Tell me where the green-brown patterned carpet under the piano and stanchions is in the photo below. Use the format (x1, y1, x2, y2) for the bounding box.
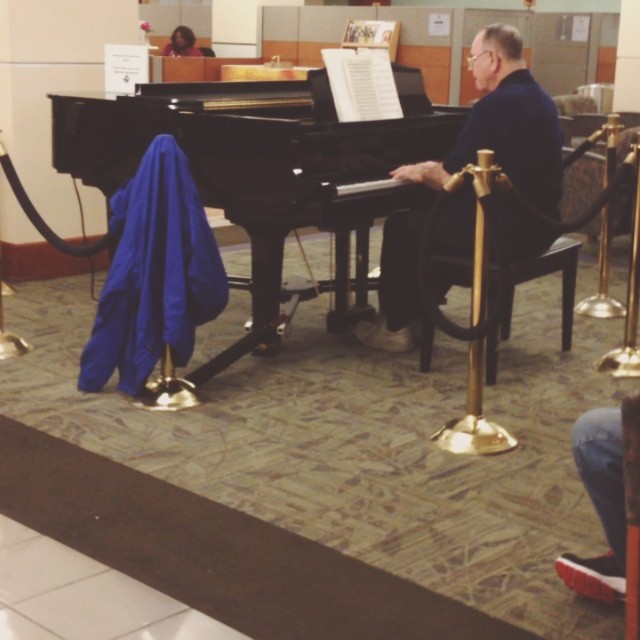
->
(0, 229, 637, 640)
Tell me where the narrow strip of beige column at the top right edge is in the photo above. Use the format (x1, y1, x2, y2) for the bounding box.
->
(613, 0, 640, 112)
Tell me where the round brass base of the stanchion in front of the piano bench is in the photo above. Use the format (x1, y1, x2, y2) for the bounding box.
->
(432, 415, 518, 456)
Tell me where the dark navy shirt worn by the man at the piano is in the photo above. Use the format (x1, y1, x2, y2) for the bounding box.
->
(443, 69, 562, 253)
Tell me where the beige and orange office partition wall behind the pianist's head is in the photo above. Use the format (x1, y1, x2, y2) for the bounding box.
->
(262, 2, 619, 104)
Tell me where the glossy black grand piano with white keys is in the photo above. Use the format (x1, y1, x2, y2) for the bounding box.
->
(49, 65, 465, 360)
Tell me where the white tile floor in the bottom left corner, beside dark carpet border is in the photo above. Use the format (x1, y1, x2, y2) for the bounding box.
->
(0, 515, 252, 640)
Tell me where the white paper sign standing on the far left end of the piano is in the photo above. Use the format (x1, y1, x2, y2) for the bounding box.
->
(104, 44, 149, 95)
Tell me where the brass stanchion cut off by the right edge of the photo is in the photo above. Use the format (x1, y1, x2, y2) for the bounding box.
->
(595, 137, 640, 378)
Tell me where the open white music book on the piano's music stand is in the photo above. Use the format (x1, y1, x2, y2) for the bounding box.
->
(322, 49, 403, 122)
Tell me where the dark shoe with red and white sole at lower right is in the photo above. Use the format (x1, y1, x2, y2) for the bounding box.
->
(556, 552, 627, 604)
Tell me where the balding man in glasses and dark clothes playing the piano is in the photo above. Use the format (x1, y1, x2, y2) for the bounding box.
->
(355, 24, 562, 352)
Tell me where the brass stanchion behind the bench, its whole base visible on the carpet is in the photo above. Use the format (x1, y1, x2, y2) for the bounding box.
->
(575, 113, 626, 319)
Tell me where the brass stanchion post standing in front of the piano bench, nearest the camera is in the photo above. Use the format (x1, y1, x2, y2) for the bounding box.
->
(432, 149, 518, 455)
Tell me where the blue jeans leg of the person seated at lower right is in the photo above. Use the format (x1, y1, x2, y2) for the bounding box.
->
(572, 407, 627, 573)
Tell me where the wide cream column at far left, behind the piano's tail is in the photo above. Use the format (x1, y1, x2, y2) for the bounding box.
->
(0, 0, 139, 245)
